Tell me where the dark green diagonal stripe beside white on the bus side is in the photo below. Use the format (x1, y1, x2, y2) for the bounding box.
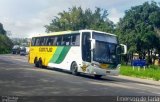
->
(56, 46, 71, 64)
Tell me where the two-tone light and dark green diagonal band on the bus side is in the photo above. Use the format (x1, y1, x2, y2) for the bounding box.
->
(50, 46, 71, 64)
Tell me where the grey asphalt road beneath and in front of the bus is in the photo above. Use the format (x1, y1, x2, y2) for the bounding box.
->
(0, 54, 160, 96)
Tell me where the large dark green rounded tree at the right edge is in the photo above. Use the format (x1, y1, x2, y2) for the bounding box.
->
(117, 1, 160, 63)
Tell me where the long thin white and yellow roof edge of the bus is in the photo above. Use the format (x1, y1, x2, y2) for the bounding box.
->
(33, 30, 116, 37)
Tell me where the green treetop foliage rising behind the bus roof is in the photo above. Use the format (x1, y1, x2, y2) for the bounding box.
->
(45, 7, 114, 33)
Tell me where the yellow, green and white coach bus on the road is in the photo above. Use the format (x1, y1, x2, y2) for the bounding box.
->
(28, 30, 127, 78)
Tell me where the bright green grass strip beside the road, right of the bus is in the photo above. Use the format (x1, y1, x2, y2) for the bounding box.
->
(120, 65, 160, 81)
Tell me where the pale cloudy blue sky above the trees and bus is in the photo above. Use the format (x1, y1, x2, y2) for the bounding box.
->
(0, 0, 160, 38)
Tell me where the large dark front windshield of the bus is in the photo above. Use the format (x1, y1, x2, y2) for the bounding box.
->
(93, 33, 117, 63)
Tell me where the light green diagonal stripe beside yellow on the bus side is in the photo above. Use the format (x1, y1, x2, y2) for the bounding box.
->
(49, 46, 64, 63)
